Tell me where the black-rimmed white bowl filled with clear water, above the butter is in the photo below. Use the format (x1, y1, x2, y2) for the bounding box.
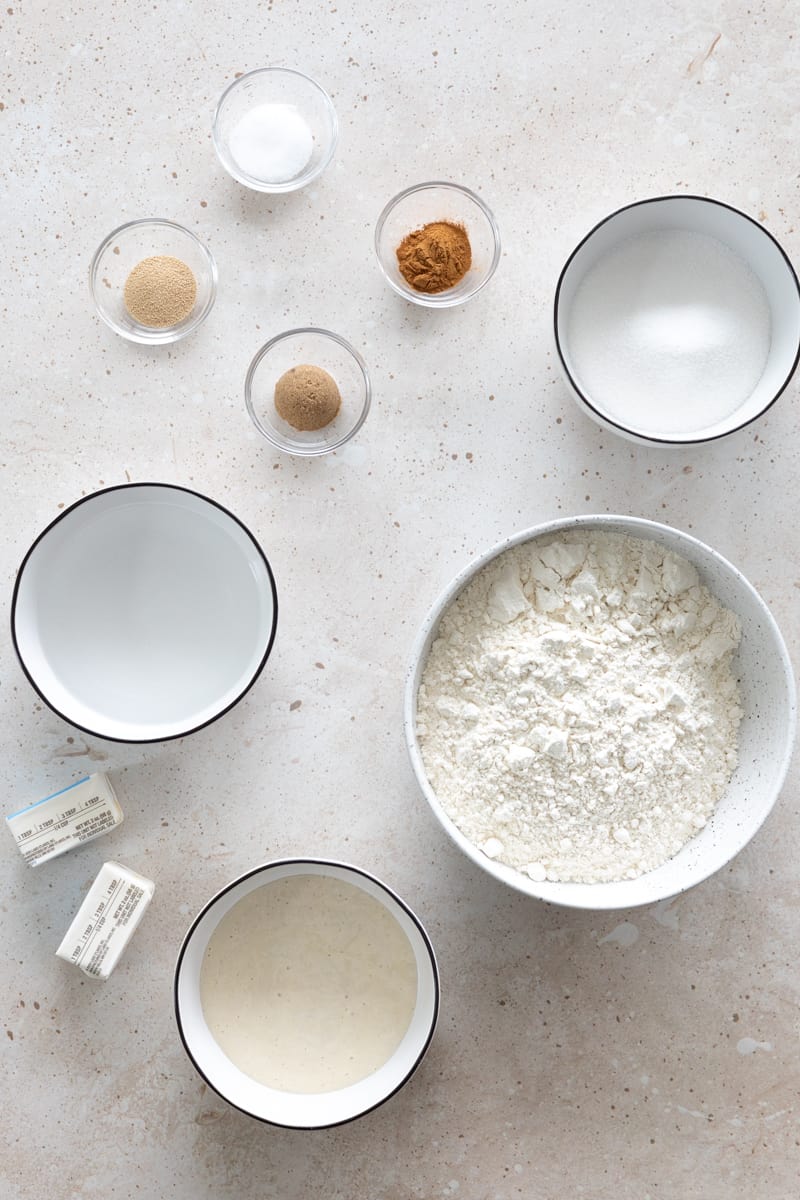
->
(11, 484, 277, 742)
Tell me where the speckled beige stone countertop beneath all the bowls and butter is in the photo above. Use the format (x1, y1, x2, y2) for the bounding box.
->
(0, 0, 800, 1200)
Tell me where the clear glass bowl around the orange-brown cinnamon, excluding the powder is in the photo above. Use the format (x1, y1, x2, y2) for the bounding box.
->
(375, 182, 500, 308)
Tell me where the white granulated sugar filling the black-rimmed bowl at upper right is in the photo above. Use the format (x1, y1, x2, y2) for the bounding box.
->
(567, 229, 770, 437)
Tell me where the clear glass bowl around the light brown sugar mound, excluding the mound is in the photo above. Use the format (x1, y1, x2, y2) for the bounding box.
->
(245, 326, 372, 457)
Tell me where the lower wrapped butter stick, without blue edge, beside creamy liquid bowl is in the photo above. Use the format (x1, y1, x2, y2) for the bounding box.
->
(55, 863, 156, 980)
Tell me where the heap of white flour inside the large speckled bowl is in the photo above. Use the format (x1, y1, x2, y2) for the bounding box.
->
(417, 532, 741, 883)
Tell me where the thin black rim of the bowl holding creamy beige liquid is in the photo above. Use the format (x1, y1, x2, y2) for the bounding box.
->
(173, 858, 440, 1130)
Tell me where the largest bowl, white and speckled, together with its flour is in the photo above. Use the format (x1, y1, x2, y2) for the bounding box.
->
(404, 516, 796, 908)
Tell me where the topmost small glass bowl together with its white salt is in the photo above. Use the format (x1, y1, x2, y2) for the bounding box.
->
(212, 67, 338, 192)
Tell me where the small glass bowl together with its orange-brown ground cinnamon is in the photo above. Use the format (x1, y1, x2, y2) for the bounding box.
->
(375, 182, 500, 308)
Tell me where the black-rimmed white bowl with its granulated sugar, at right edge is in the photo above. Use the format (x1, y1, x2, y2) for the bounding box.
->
(554, 196, 800, 445)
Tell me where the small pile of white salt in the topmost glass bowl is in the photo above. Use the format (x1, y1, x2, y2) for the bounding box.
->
(228, 104, 314, 184)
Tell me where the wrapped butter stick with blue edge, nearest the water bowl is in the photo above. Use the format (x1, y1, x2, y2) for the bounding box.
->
(6, 774, 122, 866)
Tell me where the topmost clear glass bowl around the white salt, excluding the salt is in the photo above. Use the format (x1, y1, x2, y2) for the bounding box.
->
(211, 67, 339, 192)
